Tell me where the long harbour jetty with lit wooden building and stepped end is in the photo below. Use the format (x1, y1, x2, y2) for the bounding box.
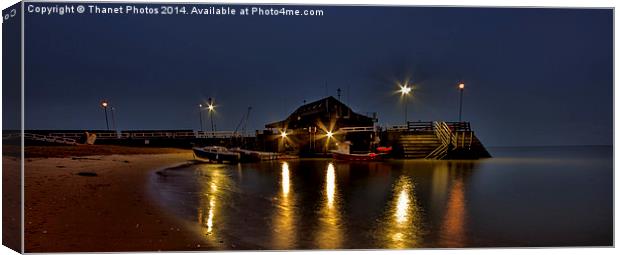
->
(12, 96, 491, 159)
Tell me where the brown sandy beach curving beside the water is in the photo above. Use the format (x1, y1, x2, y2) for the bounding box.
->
(24, 150, 225, 252)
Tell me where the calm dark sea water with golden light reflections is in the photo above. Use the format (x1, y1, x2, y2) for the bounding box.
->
(152, 147, 613, 249)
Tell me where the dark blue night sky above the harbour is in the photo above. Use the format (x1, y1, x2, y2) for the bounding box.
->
(25, 4, 613, 146)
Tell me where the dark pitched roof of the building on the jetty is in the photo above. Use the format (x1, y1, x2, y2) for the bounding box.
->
(265, 96, 374, 129)
